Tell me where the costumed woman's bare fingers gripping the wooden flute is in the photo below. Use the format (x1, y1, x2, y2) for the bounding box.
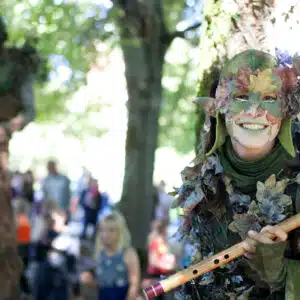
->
(243, 225, 288, 259)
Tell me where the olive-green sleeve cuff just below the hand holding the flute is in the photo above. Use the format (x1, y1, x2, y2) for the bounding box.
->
(249, 242, 288, 291)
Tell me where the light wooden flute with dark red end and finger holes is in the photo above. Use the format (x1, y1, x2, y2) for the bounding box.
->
(144, 213, 300, 300)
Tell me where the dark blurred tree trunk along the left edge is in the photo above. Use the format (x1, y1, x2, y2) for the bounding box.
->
(0, 17, 39, 299)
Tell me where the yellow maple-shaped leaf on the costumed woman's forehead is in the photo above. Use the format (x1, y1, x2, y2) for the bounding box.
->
(249, 69, 280, 95)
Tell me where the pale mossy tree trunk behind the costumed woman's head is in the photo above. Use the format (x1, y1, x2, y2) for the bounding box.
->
(196, 0, 274, 151)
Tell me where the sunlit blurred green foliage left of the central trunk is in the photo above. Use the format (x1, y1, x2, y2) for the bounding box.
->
(0, 0, 109, 138)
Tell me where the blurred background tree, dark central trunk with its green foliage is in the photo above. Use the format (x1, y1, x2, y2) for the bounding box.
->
(0, 0, 200, 247)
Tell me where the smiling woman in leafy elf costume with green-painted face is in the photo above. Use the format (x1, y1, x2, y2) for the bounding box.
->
(175, 50, 300, 300)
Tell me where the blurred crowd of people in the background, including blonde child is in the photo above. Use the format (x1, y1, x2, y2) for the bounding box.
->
(11, 161, 182, 300)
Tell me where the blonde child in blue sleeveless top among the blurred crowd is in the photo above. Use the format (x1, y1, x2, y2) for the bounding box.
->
(81, 212, 140, 300)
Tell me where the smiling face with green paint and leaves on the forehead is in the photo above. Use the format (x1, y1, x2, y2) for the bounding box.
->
(222, 69, 282, 149)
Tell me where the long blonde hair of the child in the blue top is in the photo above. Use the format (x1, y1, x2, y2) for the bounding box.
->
(95, 211, 131, 258)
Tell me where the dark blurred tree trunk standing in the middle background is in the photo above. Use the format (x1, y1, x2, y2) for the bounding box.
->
(115, 0, 168, 249)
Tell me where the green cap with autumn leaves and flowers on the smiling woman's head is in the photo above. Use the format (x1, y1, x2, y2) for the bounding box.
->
(216, 52, 300, 117)
